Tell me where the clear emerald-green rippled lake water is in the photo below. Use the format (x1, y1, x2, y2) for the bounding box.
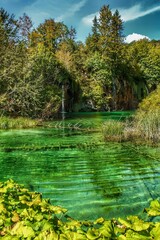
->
(0, 113, 160, 220)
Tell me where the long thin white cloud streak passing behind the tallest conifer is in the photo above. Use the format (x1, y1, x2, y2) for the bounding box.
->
(82, 4, 160, 26)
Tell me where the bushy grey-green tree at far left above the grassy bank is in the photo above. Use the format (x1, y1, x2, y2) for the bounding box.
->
(0, 43, 42, 117)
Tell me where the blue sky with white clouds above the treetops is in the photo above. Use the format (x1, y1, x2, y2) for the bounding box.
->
(0, 0, 160, 41)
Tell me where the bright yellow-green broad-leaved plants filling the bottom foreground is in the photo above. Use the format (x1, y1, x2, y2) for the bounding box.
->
(0, 180, 160, 240)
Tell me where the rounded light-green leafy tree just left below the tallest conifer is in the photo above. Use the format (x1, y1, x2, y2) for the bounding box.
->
(85, 52, 112, 110)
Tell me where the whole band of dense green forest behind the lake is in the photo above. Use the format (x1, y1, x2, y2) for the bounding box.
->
(0, 5, 160, 119)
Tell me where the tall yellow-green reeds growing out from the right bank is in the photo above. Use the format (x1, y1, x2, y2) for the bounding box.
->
(102, 108, 160, 144)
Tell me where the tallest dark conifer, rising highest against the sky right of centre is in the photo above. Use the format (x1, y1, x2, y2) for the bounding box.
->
(86, 5, 123, 109)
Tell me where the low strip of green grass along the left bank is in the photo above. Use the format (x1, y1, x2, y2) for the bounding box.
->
(0, 117, 39, 129)
